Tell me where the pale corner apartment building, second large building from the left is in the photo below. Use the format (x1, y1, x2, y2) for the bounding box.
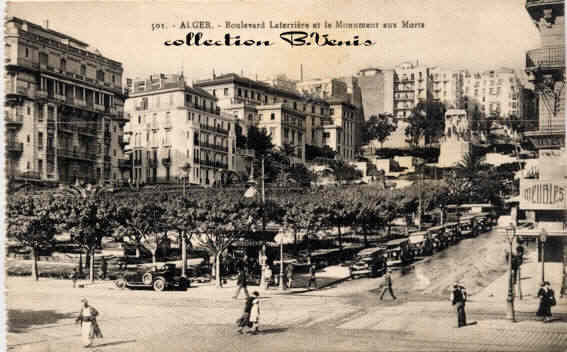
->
(125, 74, 235, 185)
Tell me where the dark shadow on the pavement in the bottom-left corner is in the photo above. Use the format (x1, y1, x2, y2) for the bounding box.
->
(8, 309, 76, 333)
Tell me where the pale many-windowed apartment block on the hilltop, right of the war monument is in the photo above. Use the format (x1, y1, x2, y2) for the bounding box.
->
(461, 68, 525, 118)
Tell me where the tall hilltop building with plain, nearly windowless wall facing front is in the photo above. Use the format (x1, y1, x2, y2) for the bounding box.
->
(357, 68, 394, 120)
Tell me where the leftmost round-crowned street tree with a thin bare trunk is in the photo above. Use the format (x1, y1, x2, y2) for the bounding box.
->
(6, 197, 58, 281)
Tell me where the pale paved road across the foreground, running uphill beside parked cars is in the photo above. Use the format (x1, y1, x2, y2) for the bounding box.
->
(7, 230, 567, 351)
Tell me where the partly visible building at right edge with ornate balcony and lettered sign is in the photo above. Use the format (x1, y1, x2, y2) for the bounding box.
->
(517, 0, 567, 289)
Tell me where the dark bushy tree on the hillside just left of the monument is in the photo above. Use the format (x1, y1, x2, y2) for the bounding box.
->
(405, 102, 445, 147)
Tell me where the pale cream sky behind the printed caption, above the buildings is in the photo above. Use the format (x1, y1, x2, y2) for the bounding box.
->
(6, 0, 540, 80)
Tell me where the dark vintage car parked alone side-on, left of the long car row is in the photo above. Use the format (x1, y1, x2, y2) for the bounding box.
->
(115, 264, 191, 291)
